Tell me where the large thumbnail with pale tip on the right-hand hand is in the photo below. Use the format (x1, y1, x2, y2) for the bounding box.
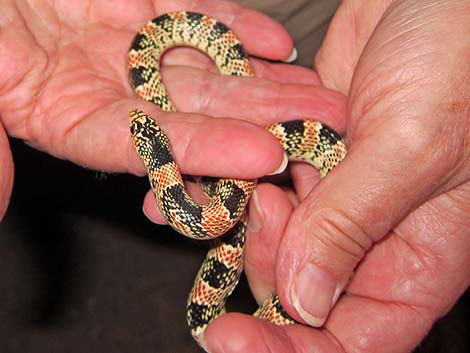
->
(291, 263, 336, 327)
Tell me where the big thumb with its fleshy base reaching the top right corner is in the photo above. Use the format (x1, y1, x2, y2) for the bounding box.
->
(276, 1, 470, 326)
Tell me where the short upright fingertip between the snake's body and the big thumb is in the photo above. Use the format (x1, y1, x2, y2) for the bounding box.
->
(245, 184, 293, 304)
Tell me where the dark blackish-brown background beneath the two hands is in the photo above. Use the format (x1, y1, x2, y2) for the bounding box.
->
(0, 135, 470, 353)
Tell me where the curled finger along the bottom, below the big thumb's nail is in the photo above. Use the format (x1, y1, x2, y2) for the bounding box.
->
(204, 183, 470, 353)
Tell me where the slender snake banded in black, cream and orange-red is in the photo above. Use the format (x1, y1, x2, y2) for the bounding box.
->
(128, 11, 347, 344)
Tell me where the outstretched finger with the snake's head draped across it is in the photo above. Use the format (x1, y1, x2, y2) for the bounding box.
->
(43, 100, 284, 178)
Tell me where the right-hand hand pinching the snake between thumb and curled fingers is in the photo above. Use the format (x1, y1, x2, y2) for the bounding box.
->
(205, 0, 470, 353)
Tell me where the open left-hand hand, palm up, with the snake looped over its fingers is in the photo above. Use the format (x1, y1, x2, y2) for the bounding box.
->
(0, 0, 345, 219)
